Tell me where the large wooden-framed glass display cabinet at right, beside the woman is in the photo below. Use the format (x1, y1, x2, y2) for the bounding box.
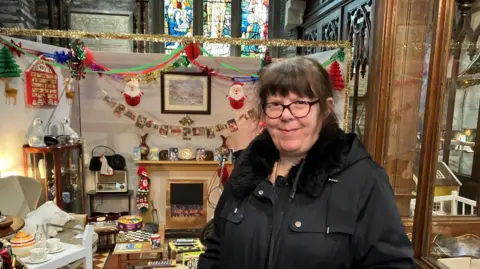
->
(365, 0, 480, 269)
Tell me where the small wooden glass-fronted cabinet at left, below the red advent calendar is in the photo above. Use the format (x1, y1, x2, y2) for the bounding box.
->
(23, 144, 85, 214)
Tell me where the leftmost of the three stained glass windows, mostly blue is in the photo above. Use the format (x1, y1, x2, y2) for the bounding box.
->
(164, 0, 193, 53)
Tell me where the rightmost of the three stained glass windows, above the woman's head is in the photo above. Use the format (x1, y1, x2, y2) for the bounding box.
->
(241, 0, 268, 57)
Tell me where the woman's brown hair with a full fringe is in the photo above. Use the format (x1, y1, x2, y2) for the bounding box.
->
(255, 56, 338, 127)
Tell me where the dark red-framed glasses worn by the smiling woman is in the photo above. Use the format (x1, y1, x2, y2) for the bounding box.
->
(263, 100, 319, 119)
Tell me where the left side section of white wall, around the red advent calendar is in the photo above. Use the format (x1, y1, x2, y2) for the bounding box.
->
(0, 36, 71, 176)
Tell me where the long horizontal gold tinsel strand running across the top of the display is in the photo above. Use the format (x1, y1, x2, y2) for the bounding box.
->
(0, 28, 351, 48)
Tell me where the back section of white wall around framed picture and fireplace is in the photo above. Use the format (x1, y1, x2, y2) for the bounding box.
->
(80, 52, 259, 218)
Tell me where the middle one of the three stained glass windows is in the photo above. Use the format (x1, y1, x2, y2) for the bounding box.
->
(203, 0, 232, 57)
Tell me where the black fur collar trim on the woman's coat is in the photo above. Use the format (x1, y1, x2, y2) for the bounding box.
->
(229, 125, 369, 199)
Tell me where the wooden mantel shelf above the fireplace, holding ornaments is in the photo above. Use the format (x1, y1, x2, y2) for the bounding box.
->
(136, 161, 233, 172)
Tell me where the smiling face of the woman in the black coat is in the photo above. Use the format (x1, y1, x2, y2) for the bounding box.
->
(264, 93, 322, 157)
